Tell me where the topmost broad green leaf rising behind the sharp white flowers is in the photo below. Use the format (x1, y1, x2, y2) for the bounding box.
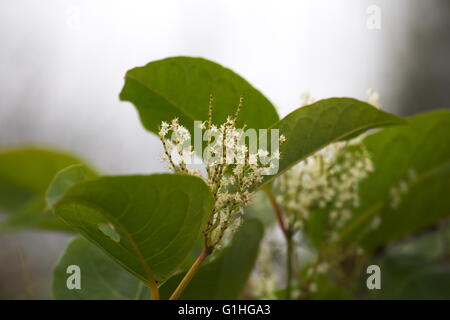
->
(120, 57, 278, 133)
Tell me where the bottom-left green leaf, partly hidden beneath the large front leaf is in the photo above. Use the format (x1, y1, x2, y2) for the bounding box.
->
(52, 236, 149, 300)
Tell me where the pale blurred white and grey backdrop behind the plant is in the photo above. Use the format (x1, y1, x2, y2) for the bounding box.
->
(0, 0, 449, 298)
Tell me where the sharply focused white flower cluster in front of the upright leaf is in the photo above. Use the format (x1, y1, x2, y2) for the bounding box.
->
(159, 98, 285, 248)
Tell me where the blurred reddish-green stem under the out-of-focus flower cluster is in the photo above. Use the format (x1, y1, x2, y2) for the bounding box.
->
(264, 186, 294, 300)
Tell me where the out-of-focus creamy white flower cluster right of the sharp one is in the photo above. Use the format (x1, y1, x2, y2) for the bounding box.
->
(275, 142, 373, 235)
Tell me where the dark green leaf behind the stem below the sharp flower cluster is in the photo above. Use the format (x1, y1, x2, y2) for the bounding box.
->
(161, 219, 263, 300)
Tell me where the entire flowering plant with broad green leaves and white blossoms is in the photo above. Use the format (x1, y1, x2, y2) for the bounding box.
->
(0, 57, 450, 299)
